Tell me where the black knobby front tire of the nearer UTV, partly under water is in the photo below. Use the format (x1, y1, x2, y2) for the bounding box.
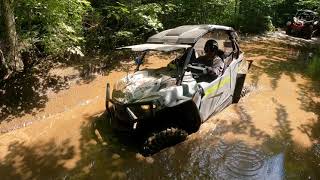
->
(141, 128, 188, 156)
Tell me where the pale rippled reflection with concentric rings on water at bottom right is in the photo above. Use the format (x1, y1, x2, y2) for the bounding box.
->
(176, 141, 283, 179)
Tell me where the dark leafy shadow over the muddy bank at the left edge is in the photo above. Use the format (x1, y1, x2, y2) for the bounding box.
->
(0, 62, 68, 123)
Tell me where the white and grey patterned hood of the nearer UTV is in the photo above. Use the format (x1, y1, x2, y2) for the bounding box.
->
(112, 71, 196, 106)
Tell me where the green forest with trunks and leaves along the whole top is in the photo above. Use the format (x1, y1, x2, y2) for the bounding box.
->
(0, 0, 320, 79)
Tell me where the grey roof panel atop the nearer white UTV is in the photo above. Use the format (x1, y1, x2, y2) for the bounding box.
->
(147, 25, 234, 44)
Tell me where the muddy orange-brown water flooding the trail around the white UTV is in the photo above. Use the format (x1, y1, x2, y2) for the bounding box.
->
(0, 32, 320, 179)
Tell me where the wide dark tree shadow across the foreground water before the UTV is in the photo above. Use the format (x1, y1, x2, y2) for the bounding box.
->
(0, 107, 319, 179)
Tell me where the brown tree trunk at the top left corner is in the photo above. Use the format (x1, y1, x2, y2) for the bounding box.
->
(0, 0, 23, 71)
